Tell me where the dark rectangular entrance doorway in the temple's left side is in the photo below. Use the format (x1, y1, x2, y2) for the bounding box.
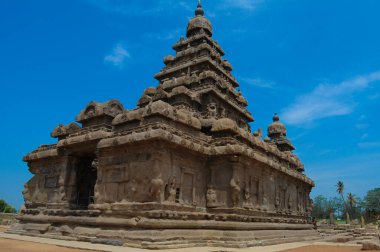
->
(75, 157, 97, 209)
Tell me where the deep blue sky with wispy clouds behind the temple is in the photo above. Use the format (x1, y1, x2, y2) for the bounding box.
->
(0, 0, 380, 207)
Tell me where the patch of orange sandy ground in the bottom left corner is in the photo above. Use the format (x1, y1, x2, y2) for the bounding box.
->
(0, 239, 94, 252)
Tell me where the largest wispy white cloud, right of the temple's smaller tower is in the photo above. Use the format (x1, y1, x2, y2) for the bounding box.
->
(282, 71, 380, 125)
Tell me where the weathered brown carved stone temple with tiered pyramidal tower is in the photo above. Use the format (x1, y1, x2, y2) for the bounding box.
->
(9, 3, 317, 249)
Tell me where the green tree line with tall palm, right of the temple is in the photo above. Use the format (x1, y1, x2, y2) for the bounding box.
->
(312, 181, 380, 222)
